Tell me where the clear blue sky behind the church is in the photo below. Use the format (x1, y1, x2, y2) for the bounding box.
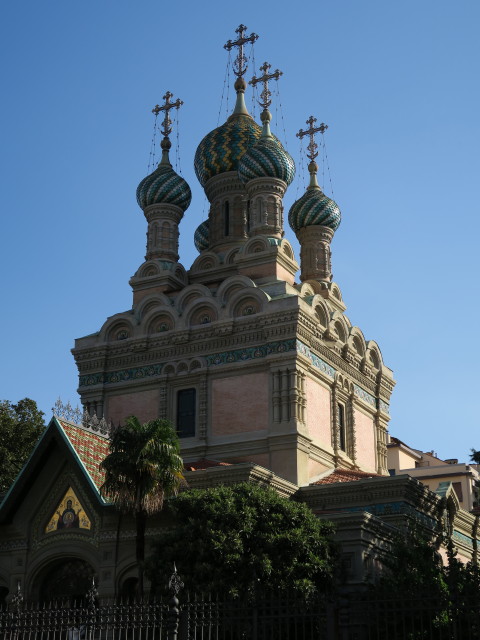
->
(0, 0, 480, 460)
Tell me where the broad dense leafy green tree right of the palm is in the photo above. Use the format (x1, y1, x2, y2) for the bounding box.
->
(147, 483, 335, 596)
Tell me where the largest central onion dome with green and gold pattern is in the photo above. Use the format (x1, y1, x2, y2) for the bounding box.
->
(194, 114, 262, 187)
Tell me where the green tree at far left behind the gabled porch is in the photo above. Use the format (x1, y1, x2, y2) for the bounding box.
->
(0, 398, 45, 493)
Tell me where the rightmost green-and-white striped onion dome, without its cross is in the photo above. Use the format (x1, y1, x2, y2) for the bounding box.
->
(288, 162, 342, 233)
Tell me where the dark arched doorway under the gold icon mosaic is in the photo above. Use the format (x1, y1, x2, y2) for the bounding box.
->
(35, 558, 95, 605)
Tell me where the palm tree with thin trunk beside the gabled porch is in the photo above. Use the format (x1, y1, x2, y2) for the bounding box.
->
(100, 416, 185, 598)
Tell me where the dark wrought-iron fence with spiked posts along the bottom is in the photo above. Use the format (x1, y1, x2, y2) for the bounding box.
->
(0, 581, 480, 640)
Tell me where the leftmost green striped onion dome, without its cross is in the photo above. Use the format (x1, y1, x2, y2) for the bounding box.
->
(137, 138, 192, 211)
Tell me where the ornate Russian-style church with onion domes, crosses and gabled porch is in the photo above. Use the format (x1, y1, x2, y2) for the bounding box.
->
(0, 25, 477, 598)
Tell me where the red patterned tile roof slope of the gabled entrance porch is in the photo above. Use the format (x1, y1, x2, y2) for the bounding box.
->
(58, 418, 109, 489)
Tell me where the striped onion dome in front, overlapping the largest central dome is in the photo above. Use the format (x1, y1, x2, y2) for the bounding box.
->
(238, 137, 295, 185)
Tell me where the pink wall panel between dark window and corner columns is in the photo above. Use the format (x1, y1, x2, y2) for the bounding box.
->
(211, 372, 269, 436)
